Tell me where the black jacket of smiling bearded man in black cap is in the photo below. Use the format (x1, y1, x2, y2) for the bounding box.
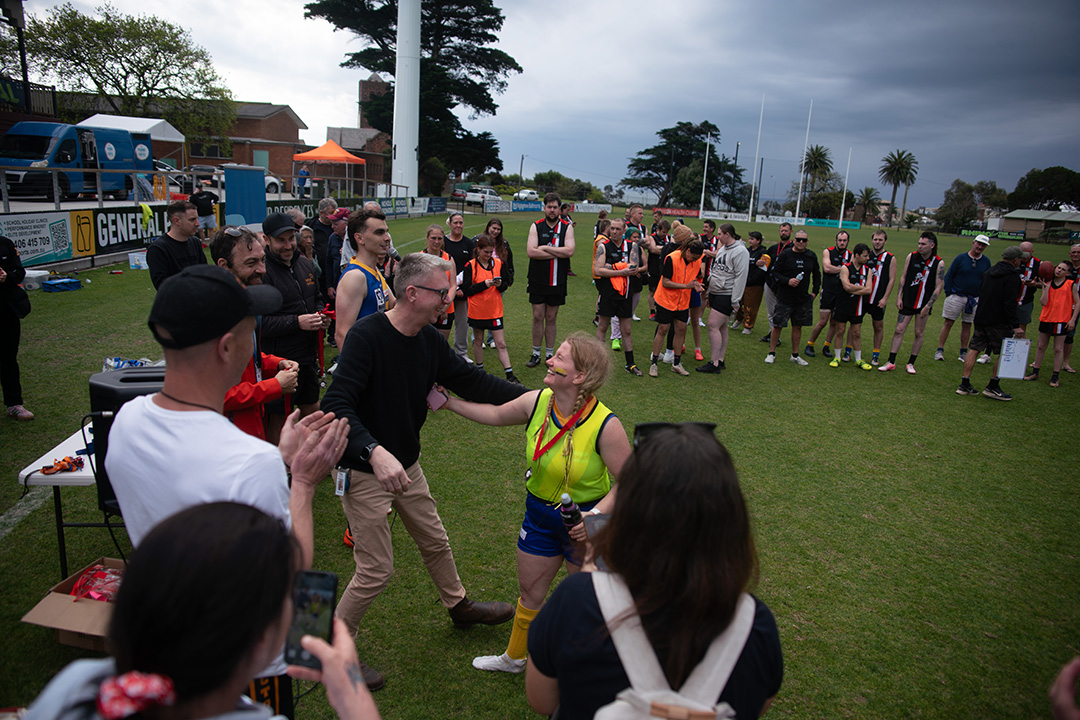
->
(261, 249, 324, 365)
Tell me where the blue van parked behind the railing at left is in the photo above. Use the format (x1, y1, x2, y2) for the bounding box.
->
(0, 122, 153, 200)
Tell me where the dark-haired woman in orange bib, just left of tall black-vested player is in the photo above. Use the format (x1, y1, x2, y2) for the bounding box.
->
(461, 234, 519, 384)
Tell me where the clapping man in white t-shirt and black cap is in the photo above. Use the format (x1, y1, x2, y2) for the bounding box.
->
(105, 266, 348, 717)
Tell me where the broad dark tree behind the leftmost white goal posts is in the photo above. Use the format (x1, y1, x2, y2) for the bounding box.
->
(620, 120, 742, 206)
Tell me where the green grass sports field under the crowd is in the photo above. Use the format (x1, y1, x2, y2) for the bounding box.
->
(0, 216, 1080, 719)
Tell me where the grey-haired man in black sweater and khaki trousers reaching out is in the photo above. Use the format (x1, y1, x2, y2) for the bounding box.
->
(322, 253, 526, 689)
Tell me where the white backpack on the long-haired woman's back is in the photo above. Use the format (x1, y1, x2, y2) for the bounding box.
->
(592, 572, 755, 720)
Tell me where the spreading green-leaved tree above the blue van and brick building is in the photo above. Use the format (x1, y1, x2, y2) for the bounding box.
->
(26, 2, 237, 144)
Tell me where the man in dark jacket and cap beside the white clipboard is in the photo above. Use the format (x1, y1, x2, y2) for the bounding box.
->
(956, 245, 1030, 400)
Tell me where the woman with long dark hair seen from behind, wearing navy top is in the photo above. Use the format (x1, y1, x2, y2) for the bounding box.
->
(525, 423, 784, 720)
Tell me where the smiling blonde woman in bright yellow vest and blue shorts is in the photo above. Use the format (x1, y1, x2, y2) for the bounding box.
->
(446, 332, 630, 673)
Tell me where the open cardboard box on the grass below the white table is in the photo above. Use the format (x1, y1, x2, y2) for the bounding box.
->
(23, 557, 124, 652)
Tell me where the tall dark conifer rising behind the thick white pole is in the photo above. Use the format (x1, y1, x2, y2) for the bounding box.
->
(305, 0, 522, 175)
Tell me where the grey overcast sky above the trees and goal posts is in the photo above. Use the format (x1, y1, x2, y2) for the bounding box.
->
(16, 0, 1080, 207)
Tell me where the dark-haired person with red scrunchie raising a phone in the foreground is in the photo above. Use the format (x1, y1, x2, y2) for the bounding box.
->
(26, 502, 379, 720)
